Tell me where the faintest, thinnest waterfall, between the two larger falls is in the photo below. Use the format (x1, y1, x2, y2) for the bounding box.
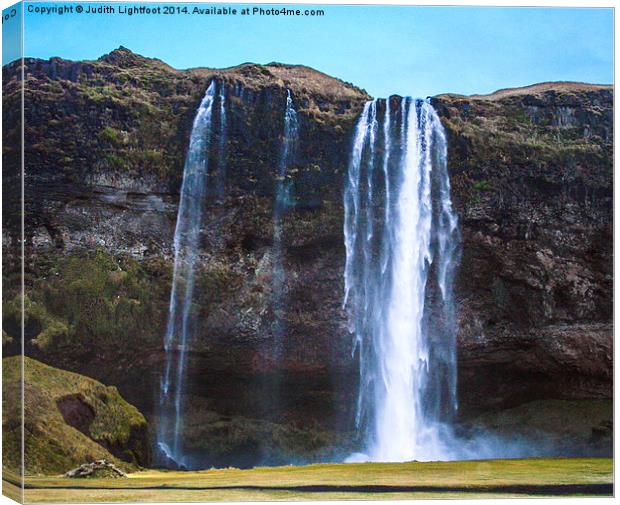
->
(272, 89, 299, 357)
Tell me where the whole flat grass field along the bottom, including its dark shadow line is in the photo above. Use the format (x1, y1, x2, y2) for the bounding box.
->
(3, 458, 613, 503)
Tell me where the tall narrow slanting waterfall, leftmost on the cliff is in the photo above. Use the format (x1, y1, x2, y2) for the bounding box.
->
(156, 80, 225, 466)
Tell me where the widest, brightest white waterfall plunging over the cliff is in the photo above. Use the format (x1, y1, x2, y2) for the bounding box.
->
(343, 97, 459, 461)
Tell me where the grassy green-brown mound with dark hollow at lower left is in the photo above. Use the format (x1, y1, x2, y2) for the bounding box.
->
(2, 356, 146, 474)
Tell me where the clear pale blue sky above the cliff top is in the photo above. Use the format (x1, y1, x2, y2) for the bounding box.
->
(3, 3, 613, 96)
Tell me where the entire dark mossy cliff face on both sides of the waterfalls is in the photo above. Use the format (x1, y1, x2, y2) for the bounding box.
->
(3, 48, 613, 464)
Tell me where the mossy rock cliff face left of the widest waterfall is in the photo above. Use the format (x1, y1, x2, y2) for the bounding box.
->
(5, 49, 369, 464)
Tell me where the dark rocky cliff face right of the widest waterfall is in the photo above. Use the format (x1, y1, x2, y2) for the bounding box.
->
(435, 83, 613, 407)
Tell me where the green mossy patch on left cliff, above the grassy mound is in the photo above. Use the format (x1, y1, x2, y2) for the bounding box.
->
(31, 250, 163, 351)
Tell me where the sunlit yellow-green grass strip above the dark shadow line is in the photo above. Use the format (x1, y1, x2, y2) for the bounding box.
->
(18, 458, 613, 499)
